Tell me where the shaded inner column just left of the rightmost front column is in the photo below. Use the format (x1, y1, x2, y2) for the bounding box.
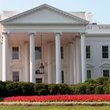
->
(76, 37, 81, 83)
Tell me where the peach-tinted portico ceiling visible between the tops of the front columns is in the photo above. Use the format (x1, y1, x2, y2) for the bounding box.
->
(9, 33, 80, 42)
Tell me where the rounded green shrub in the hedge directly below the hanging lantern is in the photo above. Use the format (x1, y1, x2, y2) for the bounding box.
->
(34, 83, 49, 95)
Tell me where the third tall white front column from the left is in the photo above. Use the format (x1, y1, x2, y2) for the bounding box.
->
(55, 33, 62, 83)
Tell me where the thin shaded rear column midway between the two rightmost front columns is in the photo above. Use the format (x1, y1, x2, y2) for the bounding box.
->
(69, 42, 74, 84)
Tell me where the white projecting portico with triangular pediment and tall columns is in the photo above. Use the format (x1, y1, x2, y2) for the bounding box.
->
(1, 4, 88, 84)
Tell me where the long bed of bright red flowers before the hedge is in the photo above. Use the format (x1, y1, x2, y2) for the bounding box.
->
(4, 94, 110, 102)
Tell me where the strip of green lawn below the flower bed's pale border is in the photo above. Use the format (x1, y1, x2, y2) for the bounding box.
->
(0, 106, 110, 110)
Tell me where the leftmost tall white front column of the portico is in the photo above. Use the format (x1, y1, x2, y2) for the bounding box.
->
(2, 33, 8, 81)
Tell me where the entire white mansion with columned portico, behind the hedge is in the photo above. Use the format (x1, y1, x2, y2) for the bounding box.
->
(0, 4, 110, 84)
